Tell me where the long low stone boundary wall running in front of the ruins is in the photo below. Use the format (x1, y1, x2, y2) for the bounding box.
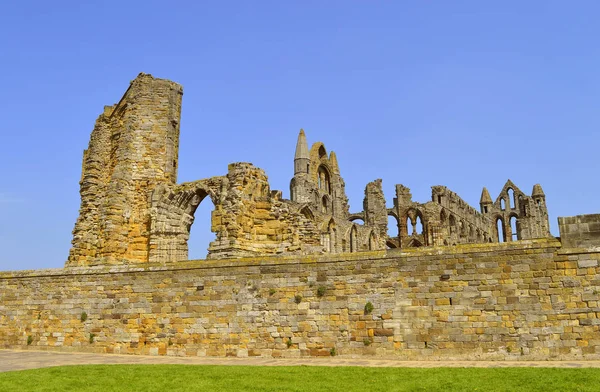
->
(0, 239, 600, 360)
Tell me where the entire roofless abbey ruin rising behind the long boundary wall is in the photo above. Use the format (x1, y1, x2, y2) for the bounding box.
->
(67, 74, 550, 266)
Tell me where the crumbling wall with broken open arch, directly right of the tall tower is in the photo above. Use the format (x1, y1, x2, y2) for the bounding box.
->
(150, 162, 332, 262)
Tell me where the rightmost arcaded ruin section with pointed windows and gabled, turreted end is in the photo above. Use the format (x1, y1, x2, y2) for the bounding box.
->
(388, 180, 551, 248)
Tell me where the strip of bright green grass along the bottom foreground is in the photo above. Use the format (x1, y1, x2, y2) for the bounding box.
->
(0, 365, 600, 392)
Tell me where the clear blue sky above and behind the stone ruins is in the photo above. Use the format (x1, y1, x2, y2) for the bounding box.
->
(0, 0, 600, 270)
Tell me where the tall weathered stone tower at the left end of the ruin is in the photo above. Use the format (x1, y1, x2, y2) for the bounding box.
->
(66, 73, 183, 266)
